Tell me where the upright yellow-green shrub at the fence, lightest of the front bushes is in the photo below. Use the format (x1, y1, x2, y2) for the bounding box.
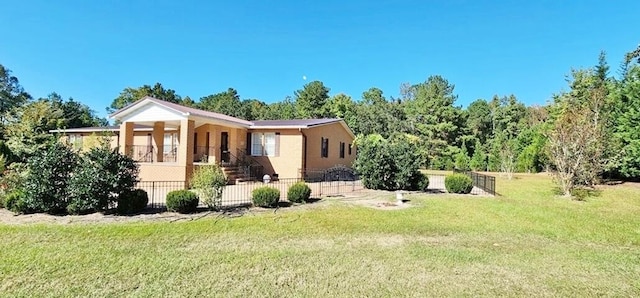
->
(191, 164, 228, 210)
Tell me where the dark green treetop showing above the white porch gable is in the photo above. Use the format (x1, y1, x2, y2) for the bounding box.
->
(107, 83, 182, 113)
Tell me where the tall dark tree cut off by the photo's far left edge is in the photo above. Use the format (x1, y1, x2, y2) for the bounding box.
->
(0, 64, 31, 138)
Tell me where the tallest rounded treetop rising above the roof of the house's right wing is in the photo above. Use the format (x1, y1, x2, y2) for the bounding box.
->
(294, 81, 330, 119)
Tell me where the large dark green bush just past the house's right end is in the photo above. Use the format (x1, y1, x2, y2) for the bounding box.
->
(354, 135, 421, 190)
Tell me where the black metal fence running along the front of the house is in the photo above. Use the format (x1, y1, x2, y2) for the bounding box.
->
(136, 178, 364, 209)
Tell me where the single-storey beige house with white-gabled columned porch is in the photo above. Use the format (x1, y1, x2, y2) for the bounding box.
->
(53, 97, 355, 181)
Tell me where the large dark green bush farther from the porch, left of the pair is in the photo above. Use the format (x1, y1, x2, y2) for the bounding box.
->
(20, 142, 78, 214)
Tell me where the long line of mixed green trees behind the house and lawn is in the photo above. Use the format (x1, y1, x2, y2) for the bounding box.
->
(0, 43, 640, 194)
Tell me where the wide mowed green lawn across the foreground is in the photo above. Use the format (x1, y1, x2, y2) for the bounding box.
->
(0, 175, 640, 297)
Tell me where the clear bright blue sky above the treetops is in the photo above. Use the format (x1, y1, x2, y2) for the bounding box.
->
(0, 0, 640, 116)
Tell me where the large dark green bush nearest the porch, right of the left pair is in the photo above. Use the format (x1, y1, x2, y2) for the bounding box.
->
(67, 144, 139, 214)
